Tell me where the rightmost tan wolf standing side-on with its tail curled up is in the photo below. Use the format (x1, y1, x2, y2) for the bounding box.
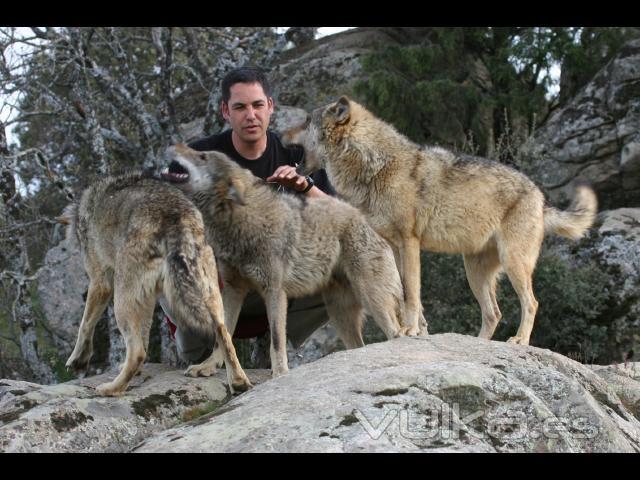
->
(283, 96, 598, 345)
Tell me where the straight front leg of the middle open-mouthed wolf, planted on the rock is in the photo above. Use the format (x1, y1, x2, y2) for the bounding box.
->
(264, 288, 289, 378)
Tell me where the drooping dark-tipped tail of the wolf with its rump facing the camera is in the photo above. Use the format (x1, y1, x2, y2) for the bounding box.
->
(163, 226, 218, 345)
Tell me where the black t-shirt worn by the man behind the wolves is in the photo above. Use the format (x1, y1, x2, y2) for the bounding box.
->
(189, 130, 336, 196)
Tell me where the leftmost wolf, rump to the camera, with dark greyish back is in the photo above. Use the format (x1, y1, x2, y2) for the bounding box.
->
(61, 172, 252, 396)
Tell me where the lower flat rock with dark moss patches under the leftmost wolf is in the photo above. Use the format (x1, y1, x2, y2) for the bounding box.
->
(0, 364, 270, 452)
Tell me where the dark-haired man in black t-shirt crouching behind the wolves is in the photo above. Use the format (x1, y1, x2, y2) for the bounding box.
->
(163, 67, 335, 367)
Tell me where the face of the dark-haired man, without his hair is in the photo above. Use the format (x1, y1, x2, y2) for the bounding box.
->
(222, 82, 273, 143)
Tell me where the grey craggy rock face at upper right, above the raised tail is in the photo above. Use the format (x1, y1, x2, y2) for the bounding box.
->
(523, 39, 640, 210)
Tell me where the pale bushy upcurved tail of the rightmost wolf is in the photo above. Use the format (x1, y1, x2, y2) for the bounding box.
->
(544, 185, 598, 240)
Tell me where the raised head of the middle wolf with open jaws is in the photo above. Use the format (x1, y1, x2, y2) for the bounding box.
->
(161, 144, 246, 205)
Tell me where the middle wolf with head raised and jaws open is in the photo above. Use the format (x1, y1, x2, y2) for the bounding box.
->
(163, 145, 403, 377)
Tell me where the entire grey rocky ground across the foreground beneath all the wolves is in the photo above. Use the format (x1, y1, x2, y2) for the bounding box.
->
(6, 334, 640, 452)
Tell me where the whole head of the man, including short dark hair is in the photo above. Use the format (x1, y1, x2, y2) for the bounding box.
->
(222, 67, 273, 143)
